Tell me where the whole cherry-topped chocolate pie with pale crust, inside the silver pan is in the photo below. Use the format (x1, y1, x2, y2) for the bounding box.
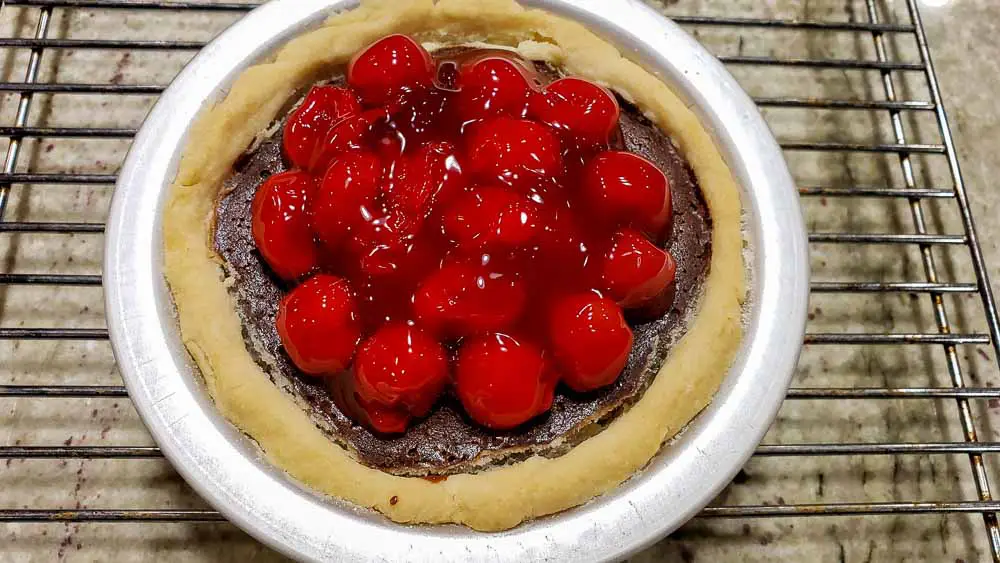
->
(164, 0, 746, 530)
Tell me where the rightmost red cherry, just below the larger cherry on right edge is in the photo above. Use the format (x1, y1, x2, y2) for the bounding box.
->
(601, 229, 677, 309)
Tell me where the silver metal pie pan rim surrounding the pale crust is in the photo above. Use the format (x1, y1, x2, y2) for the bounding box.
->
(104, 0, 809, 562)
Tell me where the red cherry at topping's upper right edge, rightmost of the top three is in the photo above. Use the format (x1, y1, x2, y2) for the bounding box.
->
(531, 77, 620, 143)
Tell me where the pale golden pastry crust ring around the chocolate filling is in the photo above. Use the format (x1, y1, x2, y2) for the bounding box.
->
(163, 0, 746, 530)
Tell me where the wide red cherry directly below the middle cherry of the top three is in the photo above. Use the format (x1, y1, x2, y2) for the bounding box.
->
(465, 117, 562, 188)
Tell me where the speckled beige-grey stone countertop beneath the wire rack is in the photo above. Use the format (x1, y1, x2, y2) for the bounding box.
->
(0, 0, 1000, 563)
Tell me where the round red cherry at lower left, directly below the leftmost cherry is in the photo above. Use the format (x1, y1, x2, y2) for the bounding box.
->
(275, 274, 361, 375)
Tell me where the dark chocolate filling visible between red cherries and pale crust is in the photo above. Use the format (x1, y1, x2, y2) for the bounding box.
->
(215, 49, 711, 475)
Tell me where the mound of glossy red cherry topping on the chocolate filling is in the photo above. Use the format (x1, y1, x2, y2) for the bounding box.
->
(220, 35, 707, 472)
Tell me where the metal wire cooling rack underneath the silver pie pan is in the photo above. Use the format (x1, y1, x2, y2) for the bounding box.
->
(0, 0, 1000, 561)
